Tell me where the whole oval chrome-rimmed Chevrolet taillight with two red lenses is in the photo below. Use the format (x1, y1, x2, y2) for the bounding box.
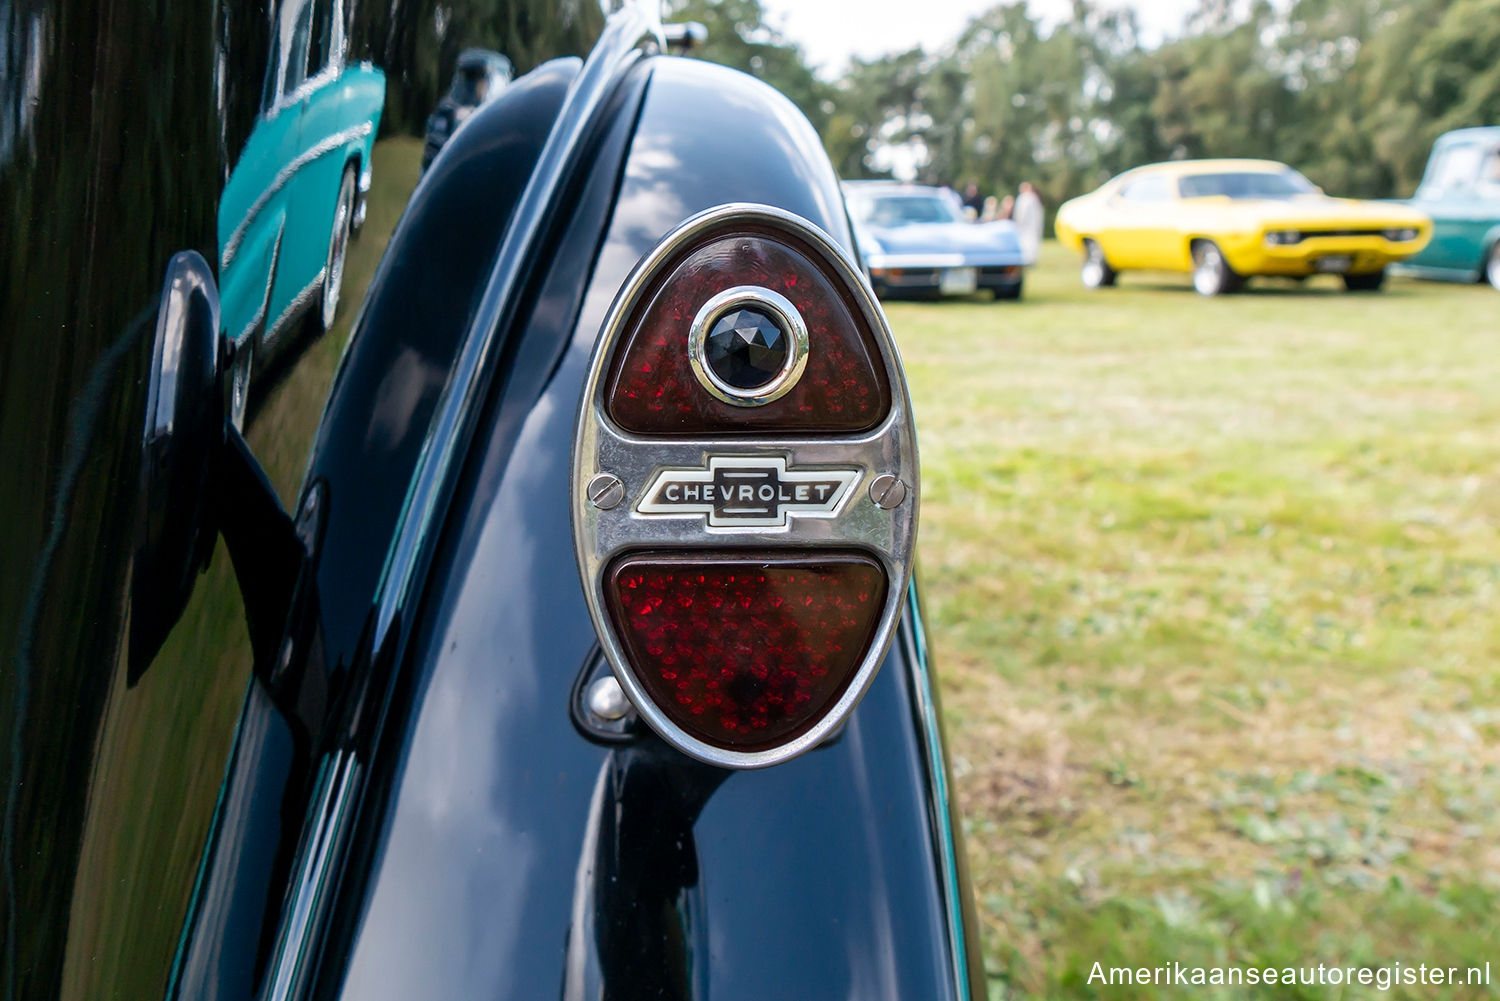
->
(573, 206, 918, 767)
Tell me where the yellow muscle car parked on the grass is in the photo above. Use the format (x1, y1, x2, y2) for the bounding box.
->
(1056, 161, 1433, 296)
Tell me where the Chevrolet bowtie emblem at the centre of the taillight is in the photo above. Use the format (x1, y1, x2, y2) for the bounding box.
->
(636, 455, 860, 528)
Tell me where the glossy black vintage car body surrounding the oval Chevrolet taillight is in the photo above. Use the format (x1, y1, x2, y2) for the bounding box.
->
(0, 0, 984, 1001)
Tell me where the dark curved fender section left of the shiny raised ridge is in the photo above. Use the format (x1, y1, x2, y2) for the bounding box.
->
(308, 59, 579, 696)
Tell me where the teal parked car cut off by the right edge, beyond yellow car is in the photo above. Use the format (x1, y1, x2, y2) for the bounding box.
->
(1401, 126, 1500, 288)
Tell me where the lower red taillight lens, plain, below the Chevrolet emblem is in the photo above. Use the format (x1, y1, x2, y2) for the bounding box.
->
(605, 551, 887, 750)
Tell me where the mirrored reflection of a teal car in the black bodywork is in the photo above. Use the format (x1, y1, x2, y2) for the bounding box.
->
(219, 0, 386, 413)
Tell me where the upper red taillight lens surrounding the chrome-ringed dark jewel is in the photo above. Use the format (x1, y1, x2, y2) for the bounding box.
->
(606, 231, 891, 435)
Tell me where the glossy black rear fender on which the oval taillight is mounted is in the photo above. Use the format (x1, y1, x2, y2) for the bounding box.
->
(323, 60, 974, 999)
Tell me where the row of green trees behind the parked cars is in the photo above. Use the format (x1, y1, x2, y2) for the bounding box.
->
(668, 0, 1500, 216)
